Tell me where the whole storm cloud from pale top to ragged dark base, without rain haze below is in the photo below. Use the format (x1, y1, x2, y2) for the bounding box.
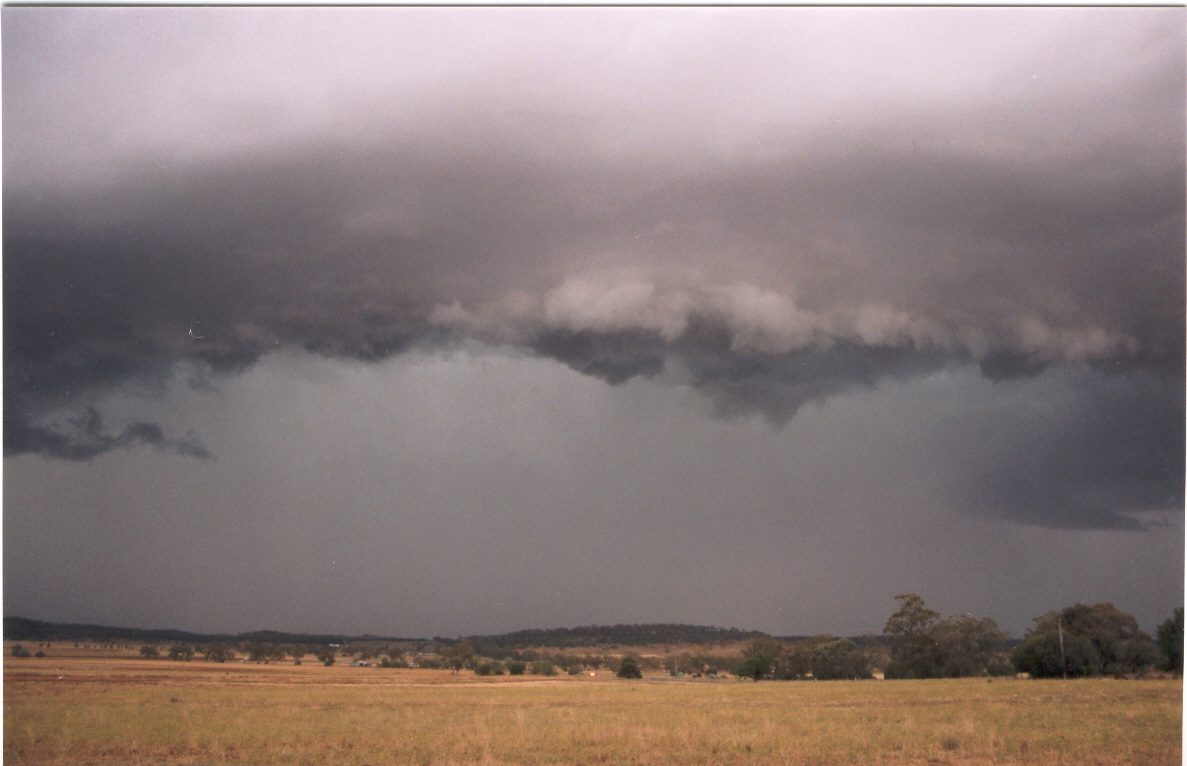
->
(4, 10, 1185, 527)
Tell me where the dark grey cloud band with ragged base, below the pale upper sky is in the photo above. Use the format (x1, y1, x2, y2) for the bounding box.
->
(5, 134, 1183, 528)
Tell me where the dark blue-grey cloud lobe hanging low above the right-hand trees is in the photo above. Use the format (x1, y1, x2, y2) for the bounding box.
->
(950, 372, 1187, 530)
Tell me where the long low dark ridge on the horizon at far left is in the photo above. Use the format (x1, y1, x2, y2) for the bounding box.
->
(4, 616, 423, 644)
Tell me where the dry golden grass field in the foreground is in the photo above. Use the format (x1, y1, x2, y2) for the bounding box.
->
(4, 657, 1182, 766)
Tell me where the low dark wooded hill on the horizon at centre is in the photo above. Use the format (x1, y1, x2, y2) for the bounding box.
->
(466, 623, 766, 651)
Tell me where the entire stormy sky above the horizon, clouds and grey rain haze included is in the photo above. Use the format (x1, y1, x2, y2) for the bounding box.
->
(0, 7, 1187, 637)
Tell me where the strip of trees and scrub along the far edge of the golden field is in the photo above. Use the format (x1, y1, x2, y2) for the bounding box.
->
(5, 594, 1183, 680)
